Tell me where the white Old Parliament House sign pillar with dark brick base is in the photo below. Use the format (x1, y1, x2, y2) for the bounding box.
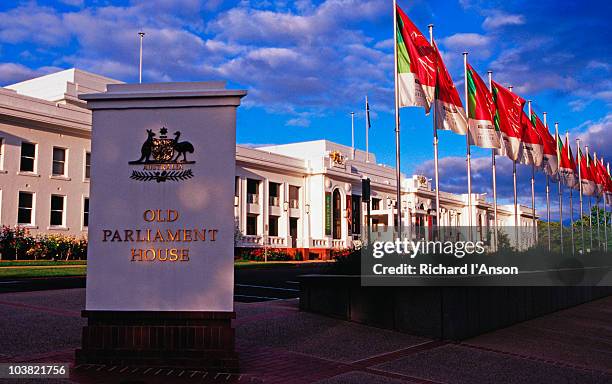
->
(77, 82, 246, 370)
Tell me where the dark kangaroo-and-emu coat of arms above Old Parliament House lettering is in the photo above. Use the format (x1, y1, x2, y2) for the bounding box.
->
(129, 127, 195, 183)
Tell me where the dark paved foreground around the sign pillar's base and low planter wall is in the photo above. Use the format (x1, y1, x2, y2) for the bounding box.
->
(0, 289, 612, 384)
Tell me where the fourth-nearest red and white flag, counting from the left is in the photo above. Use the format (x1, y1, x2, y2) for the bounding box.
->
(491, 81, 525, 160)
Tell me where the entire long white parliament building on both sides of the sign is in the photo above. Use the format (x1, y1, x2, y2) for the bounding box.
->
(0, 69, 533, 254)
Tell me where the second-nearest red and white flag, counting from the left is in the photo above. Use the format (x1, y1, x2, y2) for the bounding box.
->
(434, 42, 468, 135)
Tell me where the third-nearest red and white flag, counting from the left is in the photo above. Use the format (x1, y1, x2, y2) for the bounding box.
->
(466, 64, 500, 148)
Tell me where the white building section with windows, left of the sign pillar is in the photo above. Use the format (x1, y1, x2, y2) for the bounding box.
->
(0, 69, 118, 235)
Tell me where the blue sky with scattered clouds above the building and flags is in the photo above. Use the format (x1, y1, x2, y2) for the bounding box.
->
(0, 0, 612, 218)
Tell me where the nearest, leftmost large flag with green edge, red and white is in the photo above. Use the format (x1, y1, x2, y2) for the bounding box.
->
(395, 6, 436, 113)
